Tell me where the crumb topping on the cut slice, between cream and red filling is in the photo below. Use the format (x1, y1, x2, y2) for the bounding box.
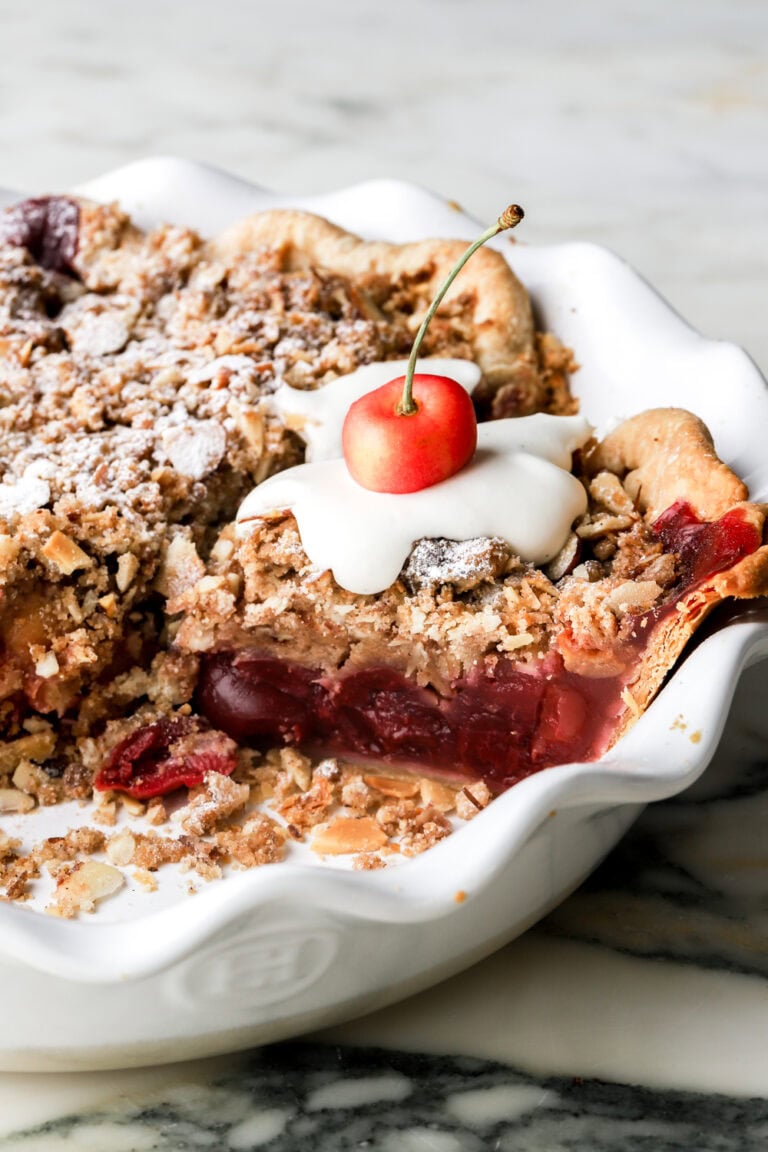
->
(176, 463, 678, 690)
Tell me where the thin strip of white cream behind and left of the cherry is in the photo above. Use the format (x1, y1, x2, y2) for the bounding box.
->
(268, 356, 480, 464)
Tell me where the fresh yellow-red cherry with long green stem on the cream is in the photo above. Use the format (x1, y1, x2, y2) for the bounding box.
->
(342, 204, 523, 494)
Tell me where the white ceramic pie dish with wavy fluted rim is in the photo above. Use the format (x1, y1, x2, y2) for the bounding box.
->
(0, 159, 768, 1070)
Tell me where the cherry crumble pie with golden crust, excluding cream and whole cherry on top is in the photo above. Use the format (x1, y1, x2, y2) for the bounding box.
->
(0, 197, 768, 820)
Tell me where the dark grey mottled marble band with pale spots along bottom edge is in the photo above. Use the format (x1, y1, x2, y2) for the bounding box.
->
(6, 1045, 768, 1152)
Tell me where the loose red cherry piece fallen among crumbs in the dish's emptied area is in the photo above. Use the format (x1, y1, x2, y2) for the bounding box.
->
(94, 717, 236, 799)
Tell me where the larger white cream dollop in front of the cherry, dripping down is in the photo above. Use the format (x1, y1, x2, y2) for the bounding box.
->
(237, 412, 592, 594)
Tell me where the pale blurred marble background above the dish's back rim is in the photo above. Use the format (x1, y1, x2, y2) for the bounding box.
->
(0, 0, 768, 367)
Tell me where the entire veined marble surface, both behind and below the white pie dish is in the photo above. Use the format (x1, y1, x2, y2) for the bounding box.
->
(0, 0, 768, 1152)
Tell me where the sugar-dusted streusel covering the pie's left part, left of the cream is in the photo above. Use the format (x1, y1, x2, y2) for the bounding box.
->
(0, 198, 569, 735)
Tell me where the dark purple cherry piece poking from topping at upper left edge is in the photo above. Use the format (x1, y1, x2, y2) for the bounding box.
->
(0, 196, 79, 275)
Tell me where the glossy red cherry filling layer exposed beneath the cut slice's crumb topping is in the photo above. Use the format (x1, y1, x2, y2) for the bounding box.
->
(198, 502, 760, 790)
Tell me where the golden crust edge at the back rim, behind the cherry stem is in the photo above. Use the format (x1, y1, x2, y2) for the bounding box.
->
(207, 210, 534, 396)
